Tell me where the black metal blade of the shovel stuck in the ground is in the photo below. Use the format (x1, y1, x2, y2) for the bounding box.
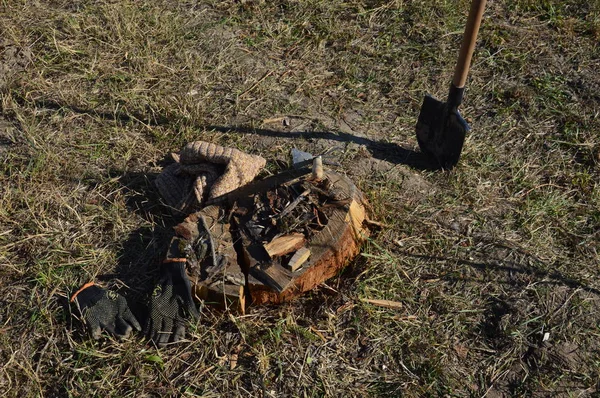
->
(416, 95, 471, 169)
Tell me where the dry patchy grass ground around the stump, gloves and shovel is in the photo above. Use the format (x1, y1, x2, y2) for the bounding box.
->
(0, 0, 600, 397)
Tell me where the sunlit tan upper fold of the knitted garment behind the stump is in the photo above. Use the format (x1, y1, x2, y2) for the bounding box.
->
(180, 141, 267, 199)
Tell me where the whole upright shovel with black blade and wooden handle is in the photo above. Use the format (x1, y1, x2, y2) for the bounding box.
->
(416, 0, 486, 169)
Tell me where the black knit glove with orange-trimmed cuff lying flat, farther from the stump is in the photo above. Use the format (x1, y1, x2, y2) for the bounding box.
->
(71, 283, 142, 339)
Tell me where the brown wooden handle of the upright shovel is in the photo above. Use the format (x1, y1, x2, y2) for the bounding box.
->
(452, 0, 486, 88)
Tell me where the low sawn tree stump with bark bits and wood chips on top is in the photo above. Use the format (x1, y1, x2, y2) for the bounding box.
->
(168, 166, 368, 312)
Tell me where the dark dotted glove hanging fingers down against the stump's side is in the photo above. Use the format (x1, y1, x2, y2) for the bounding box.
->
(144, 258, 199, 346)
